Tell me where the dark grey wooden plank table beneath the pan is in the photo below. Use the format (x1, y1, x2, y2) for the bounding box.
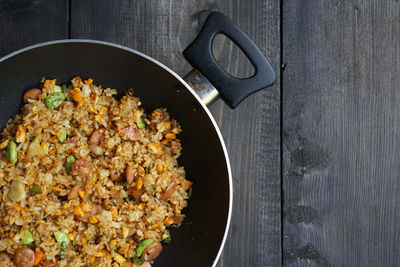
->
(0, 0, 400, 267)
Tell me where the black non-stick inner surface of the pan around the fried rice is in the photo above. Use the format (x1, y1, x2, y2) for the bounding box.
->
(0, 42, 230, 267)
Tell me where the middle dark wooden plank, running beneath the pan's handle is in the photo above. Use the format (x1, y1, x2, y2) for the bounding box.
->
(71, 0, 281, 266)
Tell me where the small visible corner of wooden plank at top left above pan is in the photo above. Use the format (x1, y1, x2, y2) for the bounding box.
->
(0, 0, 69, 56)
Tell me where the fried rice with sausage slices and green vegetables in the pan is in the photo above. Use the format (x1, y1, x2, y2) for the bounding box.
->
(0, 77, 191, 267)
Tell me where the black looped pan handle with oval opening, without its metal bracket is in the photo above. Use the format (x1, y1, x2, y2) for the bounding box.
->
(182, 12, 275, 109)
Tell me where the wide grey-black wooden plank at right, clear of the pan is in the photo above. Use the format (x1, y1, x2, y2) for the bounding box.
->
(282, 0, 400, 266)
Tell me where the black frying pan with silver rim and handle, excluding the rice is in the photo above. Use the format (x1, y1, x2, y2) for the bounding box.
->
(0, 12, 275, 267)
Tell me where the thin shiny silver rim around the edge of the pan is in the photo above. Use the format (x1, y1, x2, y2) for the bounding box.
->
(0, 39, 233, 267)
